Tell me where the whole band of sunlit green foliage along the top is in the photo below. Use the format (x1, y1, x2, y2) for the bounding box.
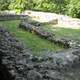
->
(0, 0, 80, 18)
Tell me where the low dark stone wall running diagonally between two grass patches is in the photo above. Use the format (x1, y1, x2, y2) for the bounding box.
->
(19, 22, 77, 48)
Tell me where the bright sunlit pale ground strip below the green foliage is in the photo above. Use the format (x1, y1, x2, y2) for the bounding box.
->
(23, 11, 80, 29)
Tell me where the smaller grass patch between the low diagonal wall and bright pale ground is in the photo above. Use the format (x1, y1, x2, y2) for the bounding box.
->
(42, 24, 80, 41)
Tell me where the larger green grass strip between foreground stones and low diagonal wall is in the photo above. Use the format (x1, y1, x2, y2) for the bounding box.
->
(0, 20, 63, 55)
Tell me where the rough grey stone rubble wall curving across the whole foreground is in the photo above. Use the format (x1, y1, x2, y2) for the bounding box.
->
(0, 24, 80, 80)
